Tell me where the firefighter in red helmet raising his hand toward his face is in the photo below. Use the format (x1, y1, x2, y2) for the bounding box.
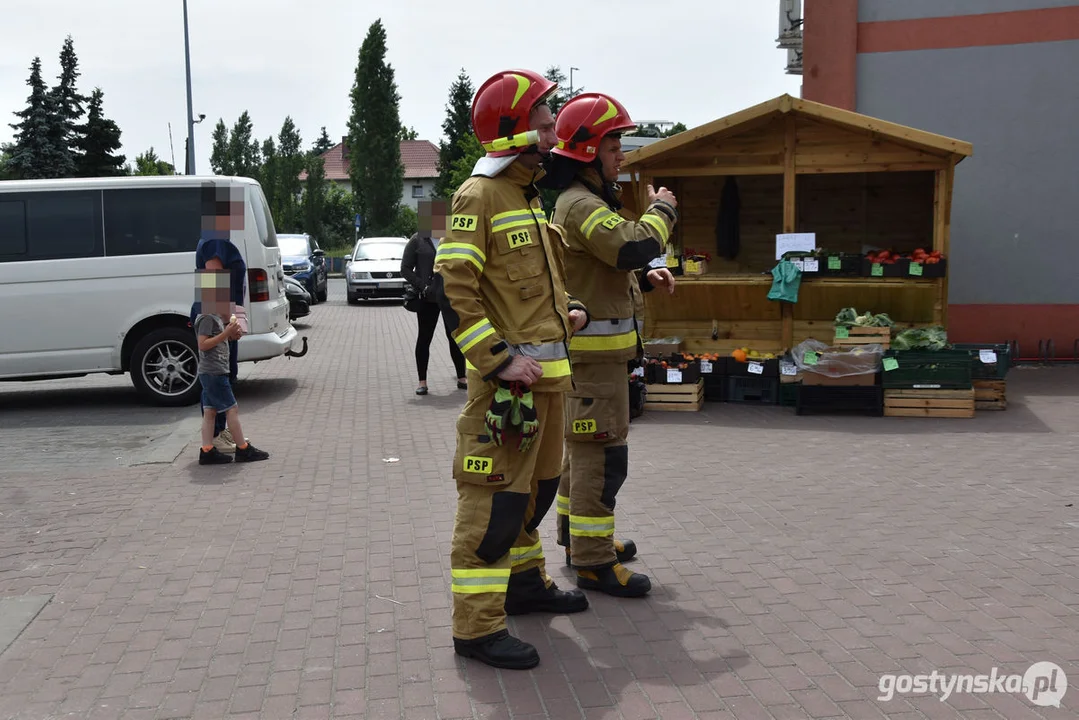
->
(547, 93, 678, 597)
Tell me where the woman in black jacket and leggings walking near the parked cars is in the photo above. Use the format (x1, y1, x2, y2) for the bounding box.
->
(401, 233, 468, 395)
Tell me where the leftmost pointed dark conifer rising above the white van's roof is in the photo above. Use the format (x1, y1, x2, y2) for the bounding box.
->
(8, 57, 71, 179)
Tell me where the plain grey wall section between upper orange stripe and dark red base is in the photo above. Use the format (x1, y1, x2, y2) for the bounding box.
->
(858, 41, 1079, 303)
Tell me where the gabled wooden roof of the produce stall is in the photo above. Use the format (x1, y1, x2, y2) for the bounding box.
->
(623, 95, 973, 176)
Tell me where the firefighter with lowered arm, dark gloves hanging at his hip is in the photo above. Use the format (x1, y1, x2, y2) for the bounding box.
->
(435, 70, 588, 669)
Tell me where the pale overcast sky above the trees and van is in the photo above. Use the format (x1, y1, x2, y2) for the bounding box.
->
(0, 0, 801, 173)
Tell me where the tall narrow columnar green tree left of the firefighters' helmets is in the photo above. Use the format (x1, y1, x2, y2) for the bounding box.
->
(349, 19, 405, 234)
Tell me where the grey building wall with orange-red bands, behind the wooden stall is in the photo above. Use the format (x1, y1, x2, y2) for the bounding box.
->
(804, 0, 1079, 356)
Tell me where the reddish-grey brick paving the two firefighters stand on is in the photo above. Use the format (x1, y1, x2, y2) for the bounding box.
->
(0, 281, 1079, 720)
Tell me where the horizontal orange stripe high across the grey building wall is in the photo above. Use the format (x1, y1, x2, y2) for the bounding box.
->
(863, 5, 1079, 57)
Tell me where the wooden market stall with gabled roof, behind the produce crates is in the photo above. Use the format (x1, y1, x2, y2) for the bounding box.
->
(623, 95, 972, 352)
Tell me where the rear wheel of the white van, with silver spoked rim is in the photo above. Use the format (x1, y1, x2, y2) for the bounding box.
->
(128, 327, 202, 407)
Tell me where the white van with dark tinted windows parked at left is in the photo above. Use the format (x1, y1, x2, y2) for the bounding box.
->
(0, 176, 306, 405)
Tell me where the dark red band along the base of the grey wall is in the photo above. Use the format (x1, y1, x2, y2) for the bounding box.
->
(947, 303, 1079, 357)
